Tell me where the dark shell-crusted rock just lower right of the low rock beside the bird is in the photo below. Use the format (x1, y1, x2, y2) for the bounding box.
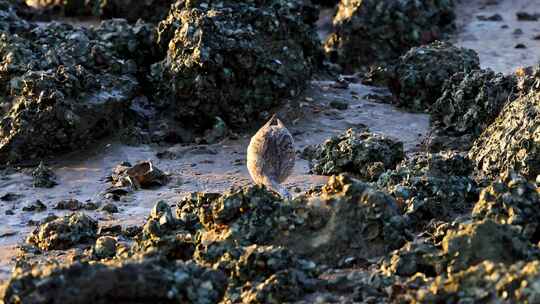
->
(377, 151, 478, 227)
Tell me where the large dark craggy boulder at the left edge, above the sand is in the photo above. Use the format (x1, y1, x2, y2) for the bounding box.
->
(0, 20, 156, 163)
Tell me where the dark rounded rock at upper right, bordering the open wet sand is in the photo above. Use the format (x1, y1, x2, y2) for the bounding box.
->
(388, 41, 480, 111)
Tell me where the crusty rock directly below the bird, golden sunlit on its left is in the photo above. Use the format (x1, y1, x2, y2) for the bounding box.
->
(177, 186, 300, 246)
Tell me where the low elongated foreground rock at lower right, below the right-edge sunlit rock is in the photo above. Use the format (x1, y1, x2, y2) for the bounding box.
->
(381, 219, 539, 277)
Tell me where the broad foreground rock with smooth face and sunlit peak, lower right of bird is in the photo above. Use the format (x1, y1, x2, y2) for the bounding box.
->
(286, 174, 409, 266)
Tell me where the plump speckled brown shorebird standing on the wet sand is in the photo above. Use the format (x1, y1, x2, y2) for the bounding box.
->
(247, 114, 295, 199)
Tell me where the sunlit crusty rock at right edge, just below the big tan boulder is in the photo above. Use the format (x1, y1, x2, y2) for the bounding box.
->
(472, 172, 540, 243)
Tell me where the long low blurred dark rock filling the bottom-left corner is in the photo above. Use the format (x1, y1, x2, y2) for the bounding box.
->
(3, 258, 227, 304)
